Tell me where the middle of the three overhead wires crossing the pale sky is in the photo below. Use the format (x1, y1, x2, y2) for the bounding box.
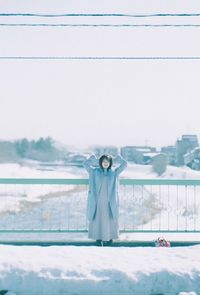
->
(0, 23, 200, 27)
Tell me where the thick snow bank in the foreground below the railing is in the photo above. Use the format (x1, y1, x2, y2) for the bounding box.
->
(0, 245, 200, 295)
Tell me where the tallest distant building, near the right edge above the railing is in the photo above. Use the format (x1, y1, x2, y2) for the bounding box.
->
(176, 134, 199, 166)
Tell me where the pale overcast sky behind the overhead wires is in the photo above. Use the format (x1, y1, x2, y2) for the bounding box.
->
(0, 0, 200, 147)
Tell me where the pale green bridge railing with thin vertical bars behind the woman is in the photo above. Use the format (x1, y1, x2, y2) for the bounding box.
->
(0, 178, 200, 234)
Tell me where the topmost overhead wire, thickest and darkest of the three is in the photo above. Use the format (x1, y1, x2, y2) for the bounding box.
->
(0, 13, 200, 18)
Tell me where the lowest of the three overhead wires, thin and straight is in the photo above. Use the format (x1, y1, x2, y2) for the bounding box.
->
(0, 56, 200, 60)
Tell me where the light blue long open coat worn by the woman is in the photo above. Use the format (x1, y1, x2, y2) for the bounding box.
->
(83, 155, 127, 221)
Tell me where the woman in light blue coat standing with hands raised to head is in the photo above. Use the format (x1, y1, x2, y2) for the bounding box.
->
(83, 154, 127, 246)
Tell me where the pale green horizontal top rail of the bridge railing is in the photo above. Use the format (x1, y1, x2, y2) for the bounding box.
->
(0, 178, 200, 186)
